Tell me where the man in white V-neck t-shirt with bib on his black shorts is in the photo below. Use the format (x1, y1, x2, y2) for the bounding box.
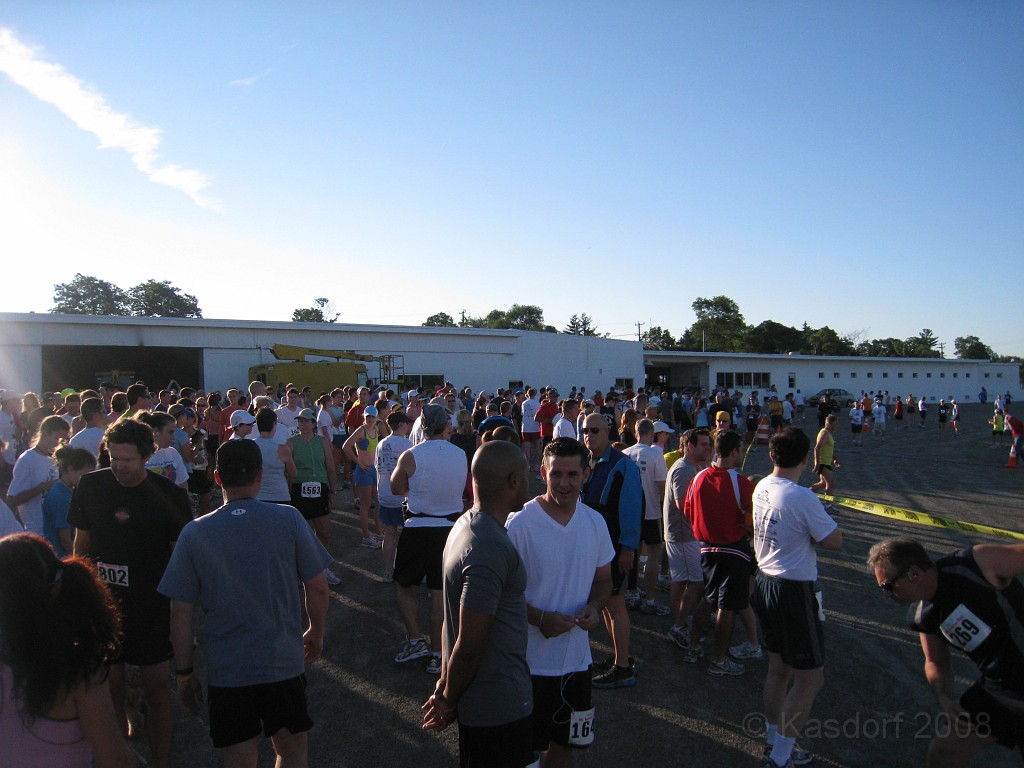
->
(505, 437, 610, 766)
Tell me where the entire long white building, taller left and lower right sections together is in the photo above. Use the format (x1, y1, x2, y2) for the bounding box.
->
(0, 312, 1021, 401)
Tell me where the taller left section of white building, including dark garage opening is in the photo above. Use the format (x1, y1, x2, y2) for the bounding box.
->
(0, 312, 644, 392)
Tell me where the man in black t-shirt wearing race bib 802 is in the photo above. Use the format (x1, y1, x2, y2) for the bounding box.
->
(68, 419, 191, 768)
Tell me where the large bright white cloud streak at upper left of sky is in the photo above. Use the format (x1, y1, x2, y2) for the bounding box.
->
(0, 28, 222, 211)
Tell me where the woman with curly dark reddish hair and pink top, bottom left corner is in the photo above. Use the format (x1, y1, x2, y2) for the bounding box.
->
(0, 534, 135, 768)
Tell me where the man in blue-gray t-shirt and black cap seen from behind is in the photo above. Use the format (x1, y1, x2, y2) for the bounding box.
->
(158, 440, 331, 765)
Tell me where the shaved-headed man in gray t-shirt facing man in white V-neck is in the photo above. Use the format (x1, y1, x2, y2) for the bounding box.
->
(423, 440, 535, 768)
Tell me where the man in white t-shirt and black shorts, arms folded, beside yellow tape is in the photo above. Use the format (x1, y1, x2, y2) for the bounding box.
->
(752, 427, 843, 767)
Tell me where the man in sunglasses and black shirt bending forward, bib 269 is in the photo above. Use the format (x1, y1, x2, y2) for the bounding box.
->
(867, 539, 1024, 766)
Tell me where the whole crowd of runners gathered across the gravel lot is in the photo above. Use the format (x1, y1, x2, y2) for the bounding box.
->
(0, 382, 1024, 768)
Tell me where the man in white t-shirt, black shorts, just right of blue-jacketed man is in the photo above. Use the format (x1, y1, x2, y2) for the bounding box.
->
(623, 419, 669, 616)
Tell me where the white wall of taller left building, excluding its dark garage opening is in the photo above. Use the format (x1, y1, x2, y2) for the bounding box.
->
(0, 313, 644, 392)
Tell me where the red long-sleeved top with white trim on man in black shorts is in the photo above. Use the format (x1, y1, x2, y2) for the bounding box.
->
(683, 466, 754, 544)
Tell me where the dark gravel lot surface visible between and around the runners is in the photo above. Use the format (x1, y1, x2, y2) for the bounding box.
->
(161, 404, 1024, 768)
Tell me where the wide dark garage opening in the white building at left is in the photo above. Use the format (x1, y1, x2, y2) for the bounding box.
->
(42, 344, 203, 392)
